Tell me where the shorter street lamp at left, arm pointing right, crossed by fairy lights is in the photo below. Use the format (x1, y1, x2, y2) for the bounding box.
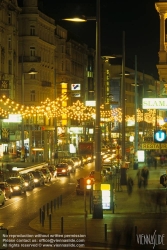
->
(21, 65, 38, 161)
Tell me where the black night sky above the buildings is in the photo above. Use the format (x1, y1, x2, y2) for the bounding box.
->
(17, 0, 160, 79)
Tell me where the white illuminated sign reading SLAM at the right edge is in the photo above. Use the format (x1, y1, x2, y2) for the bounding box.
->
(142, 98, 167, 109)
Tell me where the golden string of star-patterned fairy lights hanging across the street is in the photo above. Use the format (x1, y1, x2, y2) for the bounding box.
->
(0, 95, 163, 125)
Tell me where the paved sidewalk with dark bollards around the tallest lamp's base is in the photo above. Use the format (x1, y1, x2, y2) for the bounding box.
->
(29, 168, 167, 249)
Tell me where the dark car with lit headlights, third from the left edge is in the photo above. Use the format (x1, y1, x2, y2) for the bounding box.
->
(6, 176, 26, 194)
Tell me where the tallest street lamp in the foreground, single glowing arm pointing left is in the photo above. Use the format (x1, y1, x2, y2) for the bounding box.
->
(63, 0, 103, 219)
